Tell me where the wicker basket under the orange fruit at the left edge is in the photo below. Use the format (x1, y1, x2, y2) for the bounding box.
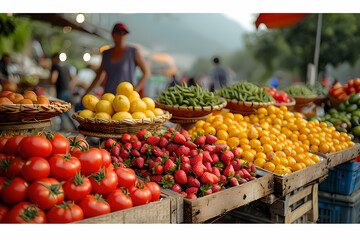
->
(0, 101, 71, 123)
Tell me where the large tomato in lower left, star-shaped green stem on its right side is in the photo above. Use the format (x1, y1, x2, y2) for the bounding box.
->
(28, 178, 65, 210)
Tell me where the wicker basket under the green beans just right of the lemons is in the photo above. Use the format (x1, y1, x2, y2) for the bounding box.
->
(155, 98, 226, 117)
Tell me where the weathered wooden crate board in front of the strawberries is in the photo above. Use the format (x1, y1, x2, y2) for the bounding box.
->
(184, 170, 274, 223)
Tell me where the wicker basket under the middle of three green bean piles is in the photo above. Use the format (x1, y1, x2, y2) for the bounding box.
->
(227, 100, 275, 116)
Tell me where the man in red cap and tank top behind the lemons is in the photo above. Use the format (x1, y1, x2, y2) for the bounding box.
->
(85, 23, 151, 95)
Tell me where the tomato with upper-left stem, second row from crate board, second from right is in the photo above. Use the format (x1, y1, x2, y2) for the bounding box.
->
(89, 167, 118, 195)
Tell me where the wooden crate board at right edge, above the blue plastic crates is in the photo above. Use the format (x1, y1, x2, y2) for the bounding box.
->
(326, 144, 360, 168)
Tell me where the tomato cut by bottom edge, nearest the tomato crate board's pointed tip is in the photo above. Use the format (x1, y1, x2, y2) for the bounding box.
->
(46, 202, 84, 223)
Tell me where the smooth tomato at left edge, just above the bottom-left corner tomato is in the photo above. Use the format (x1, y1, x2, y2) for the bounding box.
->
(1, 177, 29, 205)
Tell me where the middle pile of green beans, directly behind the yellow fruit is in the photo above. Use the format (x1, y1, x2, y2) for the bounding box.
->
(216, 81, 275, 102)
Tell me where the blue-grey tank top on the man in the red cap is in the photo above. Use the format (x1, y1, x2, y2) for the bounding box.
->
(103, 46, 137, 94)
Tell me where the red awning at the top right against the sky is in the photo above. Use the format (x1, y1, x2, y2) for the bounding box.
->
(255, 13, 310, 28)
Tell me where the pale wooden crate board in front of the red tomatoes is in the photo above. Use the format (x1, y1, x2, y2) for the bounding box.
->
(74, 189, 184, 224)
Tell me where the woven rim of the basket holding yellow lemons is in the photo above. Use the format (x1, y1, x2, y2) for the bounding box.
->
(72, 111, 172, 127)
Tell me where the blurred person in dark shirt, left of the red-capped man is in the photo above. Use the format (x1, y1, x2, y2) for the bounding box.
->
(49, 53, 76, 129)
